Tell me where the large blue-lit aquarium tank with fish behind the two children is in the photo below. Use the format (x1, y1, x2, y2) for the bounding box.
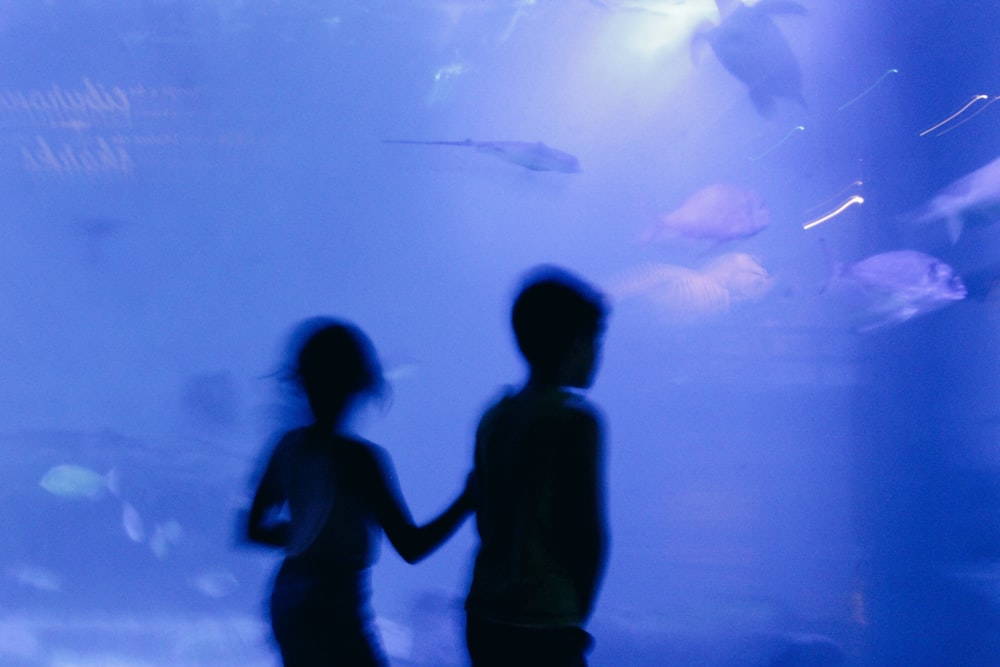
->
(0, 0, 1000, 667)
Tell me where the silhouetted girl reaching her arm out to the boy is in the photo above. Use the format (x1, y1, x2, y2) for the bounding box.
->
(248, 320, 471, 667)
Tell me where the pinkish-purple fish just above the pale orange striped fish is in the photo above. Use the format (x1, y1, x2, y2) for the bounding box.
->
(644, 183, 771, 244)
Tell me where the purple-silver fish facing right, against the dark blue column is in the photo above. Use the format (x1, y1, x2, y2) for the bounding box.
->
(831, 250, 968, 332)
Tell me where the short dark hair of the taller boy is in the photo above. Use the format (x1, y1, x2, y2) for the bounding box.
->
(511, 266, 608, 370)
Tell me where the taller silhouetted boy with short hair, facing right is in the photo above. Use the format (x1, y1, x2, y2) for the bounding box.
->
(465, 268, 608, 667)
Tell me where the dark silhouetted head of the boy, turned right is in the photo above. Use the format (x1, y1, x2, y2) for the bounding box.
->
(511, 266, 607, 387)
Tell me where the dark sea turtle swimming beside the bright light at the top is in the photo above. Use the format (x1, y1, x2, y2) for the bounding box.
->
(691, 0, 806, 116)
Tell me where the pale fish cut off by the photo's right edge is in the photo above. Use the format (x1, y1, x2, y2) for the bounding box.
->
(913, 158, 1000, 243)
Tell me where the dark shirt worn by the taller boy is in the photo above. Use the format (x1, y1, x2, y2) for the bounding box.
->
(466, 387, 607, 626)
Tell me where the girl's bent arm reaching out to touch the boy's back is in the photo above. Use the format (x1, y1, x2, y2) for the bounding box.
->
(372, 448, 473, 563)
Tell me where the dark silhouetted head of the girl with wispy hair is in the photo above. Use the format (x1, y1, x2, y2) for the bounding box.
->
(289, 318, 385, 423)
